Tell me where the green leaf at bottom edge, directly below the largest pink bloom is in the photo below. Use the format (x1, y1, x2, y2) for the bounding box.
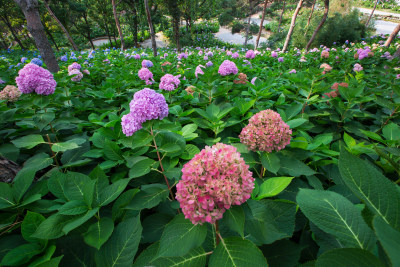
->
(208, 237, 268, 267)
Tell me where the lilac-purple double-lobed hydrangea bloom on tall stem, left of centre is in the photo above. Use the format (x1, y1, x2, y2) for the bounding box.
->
(121, 88, 168, 136)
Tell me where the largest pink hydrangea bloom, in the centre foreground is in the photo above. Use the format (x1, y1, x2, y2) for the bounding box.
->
(176, 143, 254, 224)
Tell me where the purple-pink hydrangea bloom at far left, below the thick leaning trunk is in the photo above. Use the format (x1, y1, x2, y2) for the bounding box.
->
(15, 63, 57, 95)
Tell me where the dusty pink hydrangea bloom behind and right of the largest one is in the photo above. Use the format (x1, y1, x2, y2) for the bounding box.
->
(239, 109, 292, 153)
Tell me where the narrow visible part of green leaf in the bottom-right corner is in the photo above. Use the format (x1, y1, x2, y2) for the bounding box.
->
(373, 216, 400, 266)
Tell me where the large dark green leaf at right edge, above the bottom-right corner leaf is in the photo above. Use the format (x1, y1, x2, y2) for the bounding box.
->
(339, 148, 400, 229)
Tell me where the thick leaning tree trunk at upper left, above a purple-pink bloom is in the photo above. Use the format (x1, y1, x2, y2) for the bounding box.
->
(14, 0, 60, 72)
